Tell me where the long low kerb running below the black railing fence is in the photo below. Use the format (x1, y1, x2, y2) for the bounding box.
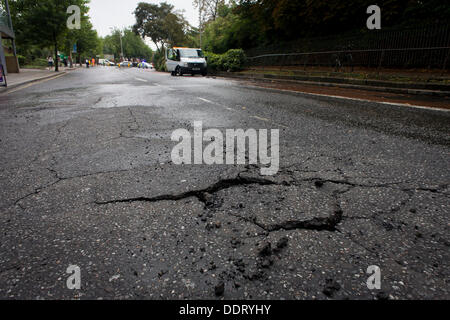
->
(216, 73, 450, 97)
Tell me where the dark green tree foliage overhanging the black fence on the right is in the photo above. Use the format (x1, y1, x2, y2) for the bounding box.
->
(197, 0, 450, 53)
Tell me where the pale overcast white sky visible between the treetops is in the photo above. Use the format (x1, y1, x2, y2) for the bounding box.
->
(89, 0, 198, 37)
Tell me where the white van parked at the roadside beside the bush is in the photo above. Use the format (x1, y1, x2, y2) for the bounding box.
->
(166, 47, 208, 76)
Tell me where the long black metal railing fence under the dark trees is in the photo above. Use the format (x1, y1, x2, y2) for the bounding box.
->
(246, 25, 450, 71)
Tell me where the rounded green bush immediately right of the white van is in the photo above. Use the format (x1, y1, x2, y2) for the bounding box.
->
(206, 49, 247, 72)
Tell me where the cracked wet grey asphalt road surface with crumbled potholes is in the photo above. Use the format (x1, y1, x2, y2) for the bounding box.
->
(0, 67, 450, 299)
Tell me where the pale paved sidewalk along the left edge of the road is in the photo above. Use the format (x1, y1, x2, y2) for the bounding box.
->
(0, 67, 75, 93)
